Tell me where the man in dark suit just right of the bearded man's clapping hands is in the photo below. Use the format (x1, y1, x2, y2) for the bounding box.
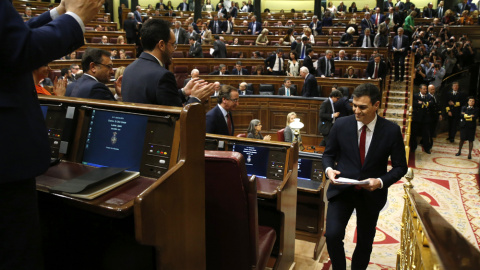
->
(206, 85, 240, 136)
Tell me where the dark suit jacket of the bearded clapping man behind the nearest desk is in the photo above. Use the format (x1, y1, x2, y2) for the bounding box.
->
(122, 52, 198, 107)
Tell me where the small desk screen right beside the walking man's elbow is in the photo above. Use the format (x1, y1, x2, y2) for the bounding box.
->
(298, 152, 323, 181)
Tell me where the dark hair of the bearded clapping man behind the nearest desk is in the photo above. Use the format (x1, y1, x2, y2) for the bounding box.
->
(140, 19, 172, 51)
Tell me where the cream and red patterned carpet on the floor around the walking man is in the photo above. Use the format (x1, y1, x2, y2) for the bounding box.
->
(295, 129, 480, 270)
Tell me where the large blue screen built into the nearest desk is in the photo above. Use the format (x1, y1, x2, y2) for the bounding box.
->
(82, 110, 148, 172)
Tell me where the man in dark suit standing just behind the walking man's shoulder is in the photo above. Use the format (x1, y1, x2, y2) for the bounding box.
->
(318, 90, 343, 146)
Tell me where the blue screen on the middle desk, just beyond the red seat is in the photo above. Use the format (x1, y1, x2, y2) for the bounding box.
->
(232, 144, 270, 177)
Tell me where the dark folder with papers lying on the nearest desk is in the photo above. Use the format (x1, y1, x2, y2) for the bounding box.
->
(50, 167, 139, 200)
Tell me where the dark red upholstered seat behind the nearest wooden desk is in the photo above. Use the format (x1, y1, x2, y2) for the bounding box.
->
(205, 151, 276, 270)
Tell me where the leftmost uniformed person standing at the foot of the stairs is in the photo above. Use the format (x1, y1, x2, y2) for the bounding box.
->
(410, 84, 432, 154)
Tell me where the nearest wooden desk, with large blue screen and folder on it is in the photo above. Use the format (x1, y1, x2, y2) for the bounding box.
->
(37, 96, 206, 269)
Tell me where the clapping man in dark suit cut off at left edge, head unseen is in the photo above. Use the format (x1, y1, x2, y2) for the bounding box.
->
(0, 0, 104, 269)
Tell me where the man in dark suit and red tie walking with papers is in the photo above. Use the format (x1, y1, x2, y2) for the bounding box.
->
(323, 83, 407, 269)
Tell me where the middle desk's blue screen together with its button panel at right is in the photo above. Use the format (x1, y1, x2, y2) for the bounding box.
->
(229, 142, 286, 180)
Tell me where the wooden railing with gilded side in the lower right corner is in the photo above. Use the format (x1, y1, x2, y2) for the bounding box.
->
(397, 169, 480, 270)
